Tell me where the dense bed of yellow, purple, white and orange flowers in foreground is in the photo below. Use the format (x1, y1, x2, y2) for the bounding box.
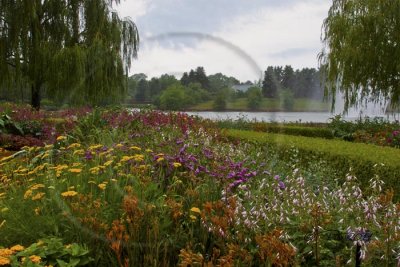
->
(0, 110, 400, 266)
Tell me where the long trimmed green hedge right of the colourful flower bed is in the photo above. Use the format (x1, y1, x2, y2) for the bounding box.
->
(225, 130, 400, 200)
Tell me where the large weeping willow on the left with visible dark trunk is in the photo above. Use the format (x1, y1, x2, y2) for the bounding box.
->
(0, 0, 139, 109)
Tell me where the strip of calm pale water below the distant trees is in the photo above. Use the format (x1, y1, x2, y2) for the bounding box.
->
(186, 111, 400, 122)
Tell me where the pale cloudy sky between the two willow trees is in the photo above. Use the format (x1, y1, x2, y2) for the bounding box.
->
(116, 0, 331, 81)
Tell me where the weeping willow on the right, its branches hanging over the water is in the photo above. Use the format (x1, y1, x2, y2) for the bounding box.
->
(320, 0, 400, 111)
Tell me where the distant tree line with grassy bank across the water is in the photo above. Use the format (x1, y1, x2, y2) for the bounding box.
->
(128, 66, 323, 110)
